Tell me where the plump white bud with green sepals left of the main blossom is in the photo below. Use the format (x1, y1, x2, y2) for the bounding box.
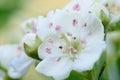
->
(23, 33, 42, 59)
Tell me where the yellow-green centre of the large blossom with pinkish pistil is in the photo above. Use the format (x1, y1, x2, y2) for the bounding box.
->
(59, 34, 85, 60)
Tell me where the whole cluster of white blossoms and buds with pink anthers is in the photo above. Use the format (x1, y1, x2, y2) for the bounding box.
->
(0, 0, 120, 80)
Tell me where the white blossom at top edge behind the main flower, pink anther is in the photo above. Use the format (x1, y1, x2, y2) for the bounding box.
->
(64, 0, 109, 17)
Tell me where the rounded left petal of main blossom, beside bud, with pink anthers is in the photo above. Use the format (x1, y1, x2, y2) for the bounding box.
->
(38, 35, 66, 59)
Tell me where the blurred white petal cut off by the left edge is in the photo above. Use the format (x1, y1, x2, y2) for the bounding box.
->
(0, 44, 18, 69)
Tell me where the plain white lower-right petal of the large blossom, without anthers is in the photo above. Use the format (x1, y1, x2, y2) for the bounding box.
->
(73, 41, 105, 72)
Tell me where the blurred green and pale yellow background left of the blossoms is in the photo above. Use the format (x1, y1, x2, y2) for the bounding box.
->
(0, 0, 70, 80)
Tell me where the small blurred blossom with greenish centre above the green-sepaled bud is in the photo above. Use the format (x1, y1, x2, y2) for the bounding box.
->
(21, 18, 37, 34)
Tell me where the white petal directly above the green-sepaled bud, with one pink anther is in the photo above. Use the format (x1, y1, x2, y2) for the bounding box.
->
(37, 13, 54, 40)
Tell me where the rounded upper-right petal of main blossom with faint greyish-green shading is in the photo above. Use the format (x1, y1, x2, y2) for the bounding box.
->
(76, 13, 104, 42)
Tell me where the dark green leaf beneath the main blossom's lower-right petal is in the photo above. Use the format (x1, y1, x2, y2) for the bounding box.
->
(65, 52, 106, 80)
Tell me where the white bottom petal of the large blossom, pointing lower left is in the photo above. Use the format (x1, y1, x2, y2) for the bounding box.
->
(36, 57, 72, 80)
